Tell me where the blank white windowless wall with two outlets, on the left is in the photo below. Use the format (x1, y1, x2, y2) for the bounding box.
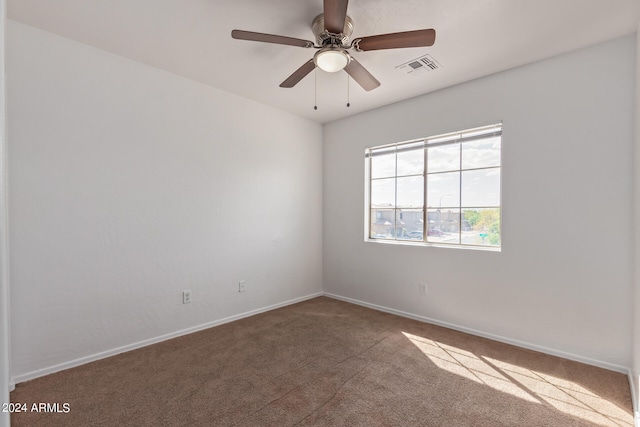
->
(7, 21, 322, 381)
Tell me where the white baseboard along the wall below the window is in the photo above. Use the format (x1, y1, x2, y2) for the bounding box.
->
(323, 292, 640, 376)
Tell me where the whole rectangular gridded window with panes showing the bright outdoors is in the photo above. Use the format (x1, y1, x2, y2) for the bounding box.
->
(365, 123, 502, 248)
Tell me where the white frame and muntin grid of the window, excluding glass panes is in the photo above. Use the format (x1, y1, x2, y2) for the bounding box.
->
(364, 122, 504, 251)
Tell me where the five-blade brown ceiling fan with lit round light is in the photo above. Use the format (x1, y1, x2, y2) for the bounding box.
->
(231, 0, 436, 91)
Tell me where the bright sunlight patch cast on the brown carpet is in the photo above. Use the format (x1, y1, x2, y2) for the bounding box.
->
(403, 332, 630, 426)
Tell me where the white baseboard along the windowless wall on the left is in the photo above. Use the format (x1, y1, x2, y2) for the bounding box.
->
(13, 292, 323, 388)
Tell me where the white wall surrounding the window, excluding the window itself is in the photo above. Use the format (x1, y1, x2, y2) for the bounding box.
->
(324, 36, 635, 370)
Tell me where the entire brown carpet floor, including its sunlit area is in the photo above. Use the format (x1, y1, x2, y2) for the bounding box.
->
(11, 297, 633, 427)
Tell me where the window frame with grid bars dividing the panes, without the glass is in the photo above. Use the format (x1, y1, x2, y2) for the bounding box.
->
(364, 121, 504, 252)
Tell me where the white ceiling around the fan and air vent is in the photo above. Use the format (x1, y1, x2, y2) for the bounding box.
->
(7, 0, 640, 123)
